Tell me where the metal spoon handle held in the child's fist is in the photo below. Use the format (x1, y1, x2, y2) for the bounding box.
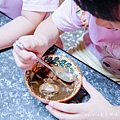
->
(15, 41, 53, 71)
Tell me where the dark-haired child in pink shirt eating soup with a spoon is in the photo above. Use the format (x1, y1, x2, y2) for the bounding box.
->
(13, 0, 120, 120)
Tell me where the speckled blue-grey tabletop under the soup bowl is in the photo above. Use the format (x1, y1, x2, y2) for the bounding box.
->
(0, 14, 120, 120)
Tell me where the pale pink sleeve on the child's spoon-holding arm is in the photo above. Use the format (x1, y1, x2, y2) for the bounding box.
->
(52, 0, 83, 32)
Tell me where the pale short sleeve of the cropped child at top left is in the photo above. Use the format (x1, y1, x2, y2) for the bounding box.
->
(22, 0, 59, 12)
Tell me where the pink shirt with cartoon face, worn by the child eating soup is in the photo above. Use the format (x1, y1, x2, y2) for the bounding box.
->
(52, 0, 120, 75)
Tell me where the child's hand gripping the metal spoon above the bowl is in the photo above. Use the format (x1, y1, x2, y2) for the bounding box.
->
(13, 35, 48, 70)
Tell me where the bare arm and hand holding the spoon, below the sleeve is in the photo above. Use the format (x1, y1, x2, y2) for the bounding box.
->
(13, 17, 62, 70)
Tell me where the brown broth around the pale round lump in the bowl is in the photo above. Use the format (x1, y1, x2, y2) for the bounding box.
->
(30, 67, 75, 100)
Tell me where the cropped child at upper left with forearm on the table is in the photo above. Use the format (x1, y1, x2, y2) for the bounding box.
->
(0, 0, 62, 50)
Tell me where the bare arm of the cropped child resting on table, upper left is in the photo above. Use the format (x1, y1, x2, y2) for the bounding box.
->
(0, 11, 46, 50)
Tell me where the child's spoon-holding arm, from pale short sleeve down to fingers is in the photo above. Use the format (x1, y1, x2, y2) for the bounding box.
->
(13, 0, 81, 70)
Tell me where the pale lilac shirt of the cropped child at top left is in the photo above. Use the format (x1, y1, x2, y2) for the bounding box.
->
(0, 0, 59, 19)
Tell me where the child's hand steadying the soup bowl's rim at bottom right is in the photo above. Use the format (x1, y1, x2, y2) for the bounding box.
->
(46, 78, 119, 120)
